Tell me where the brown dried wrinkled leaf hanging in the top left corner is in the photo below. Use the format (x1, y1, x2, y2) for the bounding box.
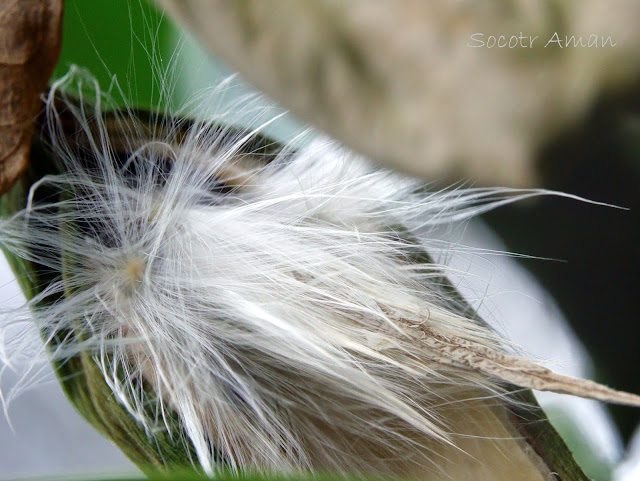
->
(0, 0, 63, 194)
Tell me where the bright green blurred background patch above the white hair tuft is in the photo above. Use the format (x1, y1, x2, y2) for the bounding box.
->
(52, 0, 303, 141)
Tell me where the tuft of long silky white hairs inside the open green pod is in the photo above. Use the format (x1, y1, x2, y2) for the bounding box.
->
(0, 70, 636, 475)
